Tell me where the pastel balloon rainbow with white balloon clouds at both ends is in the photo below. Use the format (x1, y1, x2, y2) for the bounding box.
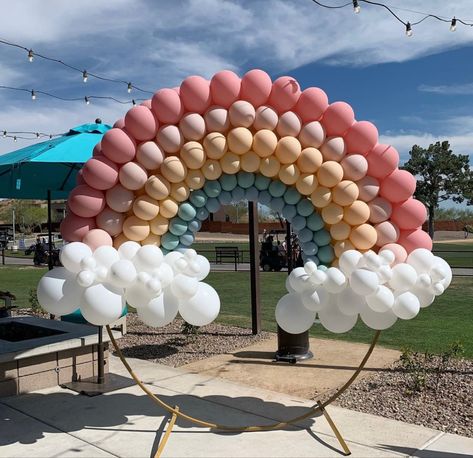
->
(38, 69, 452, 454)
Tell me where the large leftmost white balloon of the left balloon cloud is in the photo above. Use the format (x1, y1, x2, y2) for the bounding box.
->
(36, 267, 84, 316)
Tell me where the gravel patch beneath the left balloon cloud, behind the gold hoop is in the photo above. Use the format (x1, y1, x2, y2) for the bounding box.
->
(112, 314, 270, 367)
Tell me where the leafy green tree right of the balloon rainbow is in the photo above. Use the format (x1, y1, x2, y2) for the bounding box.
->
(403, 141, 473, 237)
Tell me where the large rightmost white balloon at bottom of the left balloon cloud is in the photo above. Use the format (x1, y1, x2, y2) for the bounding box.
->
(179, 282, 220, 326)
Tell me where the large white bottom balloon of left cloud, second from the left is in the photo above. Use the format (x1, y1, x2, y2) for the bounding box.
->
(80, 283, 125, 326)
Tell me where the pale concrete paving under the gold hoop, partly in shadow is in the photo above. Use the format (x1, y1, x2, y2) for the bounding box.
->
(0, 357, 473, 458)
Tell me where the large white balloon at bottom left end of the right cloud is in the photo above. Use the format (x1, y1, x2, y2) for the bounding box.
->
(275, 294, 316, 334)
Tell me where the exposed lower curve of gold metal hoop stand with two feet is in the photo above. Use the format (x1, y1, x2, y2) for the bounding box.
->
(107, 325, 381, 457)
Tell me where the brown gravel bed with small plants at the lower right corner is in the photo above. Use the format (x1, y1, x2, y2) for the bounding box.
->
(337, 358, 473, 437)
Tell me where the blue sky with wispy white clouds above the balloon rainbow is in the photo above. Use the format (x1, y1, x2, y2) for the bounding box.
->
(0, 0, 473, 165)
